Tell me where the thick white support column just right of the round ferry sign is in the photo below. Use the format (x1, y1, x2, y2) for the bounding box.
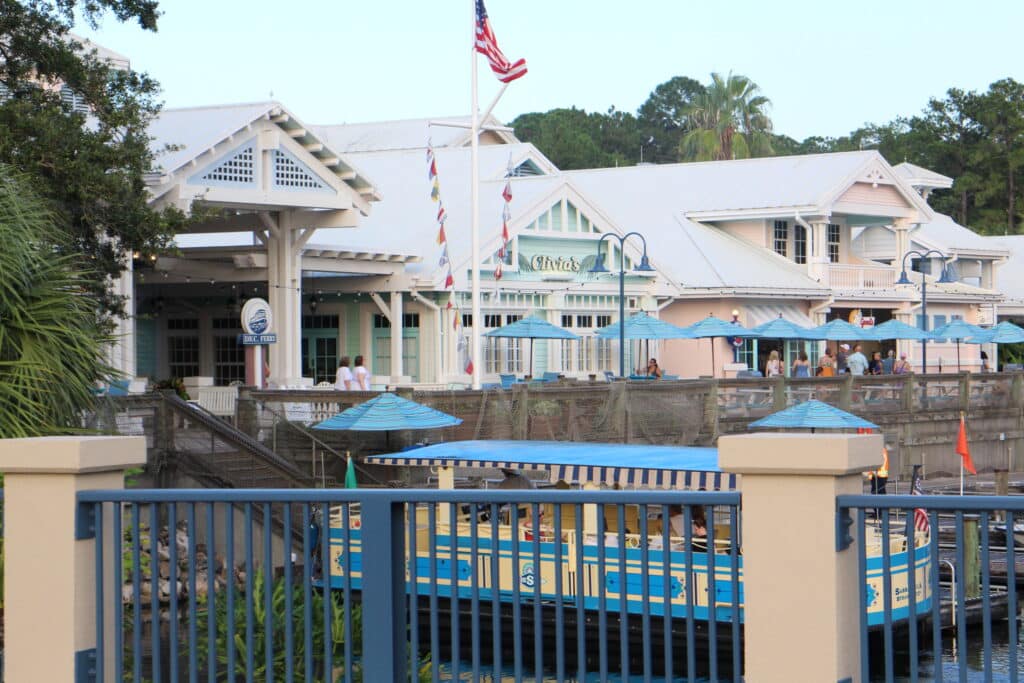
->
(266, 211, 303, 386)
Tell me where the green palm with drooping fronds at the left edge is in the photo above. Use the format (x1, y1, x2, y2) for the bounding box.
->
(0, 166, 111, 438)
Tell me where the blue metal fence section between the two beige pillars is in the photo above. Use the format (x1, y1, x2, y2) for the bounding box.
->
(78, 489, 742, 683)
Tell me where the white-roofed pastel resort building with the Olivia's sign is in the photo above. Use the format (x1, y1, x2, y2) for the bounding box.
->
(118, 102, 1003, 387)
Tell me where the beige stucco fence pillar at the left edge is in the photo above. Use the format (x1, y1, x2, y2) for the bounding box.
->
(0, 436, 145, 682)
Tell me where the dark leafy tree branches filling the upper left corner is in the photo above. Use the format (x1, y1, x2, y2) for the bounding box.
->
(0, 0, 191, 312)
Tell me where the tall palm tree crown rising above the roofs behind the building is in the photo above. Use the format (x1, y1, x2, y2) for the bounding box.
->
(679, 73, 772, 161)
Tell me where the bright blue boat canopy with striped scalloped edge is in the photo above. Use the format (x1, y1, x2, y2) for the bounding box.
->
(366, 440, 736, 490)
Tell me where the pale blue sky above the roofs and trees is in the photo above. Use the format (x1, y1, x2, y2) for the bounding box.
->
(78, 0, 1024, 139)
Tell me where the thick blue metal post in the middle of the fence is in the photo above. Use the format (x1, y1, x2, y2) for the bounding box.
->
(360, 494, 407, 681)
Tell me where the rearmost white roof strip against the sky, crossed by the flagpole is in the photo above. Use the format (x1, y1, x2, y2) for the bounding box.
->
(312, 116, 519, 153)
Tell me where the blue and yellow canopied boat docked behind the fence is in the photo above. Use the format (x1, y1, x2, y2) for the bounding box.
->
(330, 440, 932, 626)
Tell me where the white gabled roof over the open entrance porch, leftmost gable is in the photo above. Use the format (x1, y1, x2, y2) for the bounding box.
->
(148, 101, 380, 200)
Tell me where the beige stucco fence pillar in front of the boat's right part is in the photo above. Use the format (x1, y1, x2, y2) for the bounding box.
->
(718, 433, 882, 683)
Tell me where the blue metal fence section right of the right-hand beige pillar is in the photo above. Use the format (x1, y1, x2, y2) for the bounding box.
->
(837, 496, 1024, 682)
